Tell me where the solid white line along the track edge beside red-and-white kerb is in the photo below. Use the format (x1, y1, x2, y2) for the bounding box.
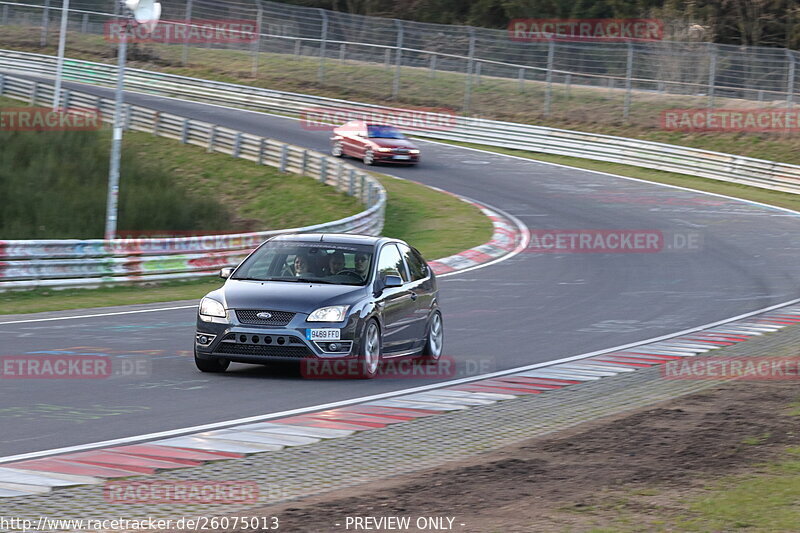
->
(0, 298, 800, 464)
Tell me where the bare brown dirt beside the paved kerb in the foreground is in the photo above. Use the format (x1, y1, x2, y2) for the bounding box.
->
(230, 382, 800, 533)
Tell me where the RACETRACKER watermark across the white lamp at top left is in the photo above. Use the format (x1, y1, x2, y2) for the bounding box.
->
(103, 19, 258, 44)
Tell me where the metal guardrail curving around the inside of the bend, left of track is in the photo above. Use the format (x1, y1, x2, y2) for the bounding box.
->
(0, 73, 386, 292)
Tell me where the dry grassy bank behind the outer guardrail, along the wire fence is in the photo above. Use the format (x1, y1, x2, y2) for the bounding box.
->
(0, 26, 800, 164)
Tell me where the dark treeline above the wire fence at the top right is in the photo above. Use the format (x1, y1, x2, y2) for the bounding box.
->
(282, 0, 800, 49)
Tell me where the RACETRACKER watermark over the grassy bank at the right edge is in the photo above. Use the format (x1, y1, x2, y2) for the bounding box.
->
(661, 107, 800, 133)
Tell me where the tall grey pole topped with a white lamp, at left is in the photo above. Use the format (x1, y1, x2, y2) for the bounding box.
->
(105, 0, 161, 240)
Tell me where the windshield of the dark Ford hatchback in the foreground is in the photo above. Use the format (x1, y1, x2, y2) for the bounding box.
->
(232, 241, 373, 285)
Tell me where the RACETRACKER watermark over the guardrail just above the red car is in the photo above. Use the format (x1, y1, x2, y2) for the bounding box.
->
(300, 107, 456, 131)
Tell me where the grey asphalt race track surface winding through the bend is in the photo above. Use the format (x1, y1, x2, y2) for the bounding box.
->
(0, 75, 800, 456)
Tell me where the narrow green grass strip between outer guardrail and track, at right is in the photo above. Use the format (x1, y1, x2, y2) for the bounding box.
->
(438, 141, 800, 211)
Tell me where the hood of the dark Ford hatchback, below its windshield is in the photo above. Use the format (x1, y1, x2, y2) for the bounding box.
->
(220, 279, 367, 313)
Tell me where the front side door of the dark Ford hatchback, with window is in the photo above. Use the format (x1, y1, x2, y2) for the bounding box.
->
(375, 243, 416, 355)
